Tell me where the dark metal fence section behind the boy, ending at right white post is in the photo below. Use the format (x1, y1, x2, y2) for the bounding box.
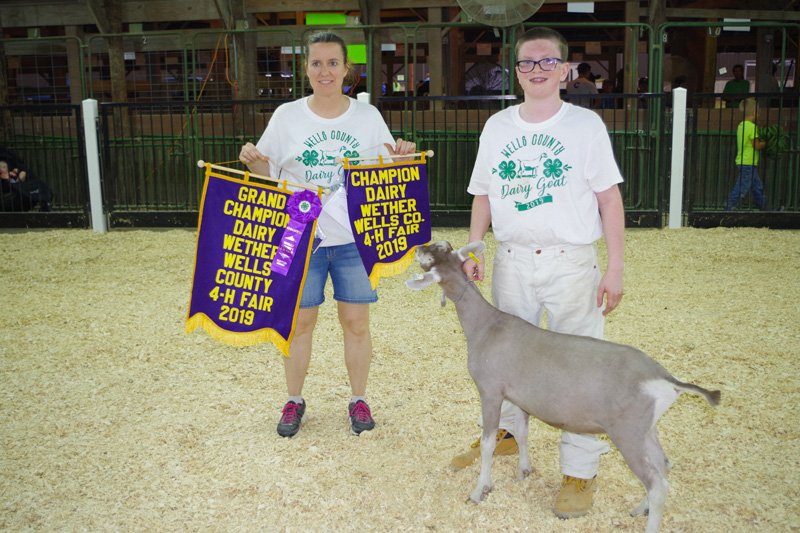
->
(379, 94, 665, 226)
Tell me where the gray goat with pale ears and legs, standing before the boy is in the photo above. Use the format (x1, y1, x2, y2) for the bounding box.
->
(406, 241, 720, 533)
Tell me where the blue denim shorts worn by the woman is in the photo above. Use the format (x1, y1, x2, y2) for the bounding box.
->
(300, 242, 378, 309)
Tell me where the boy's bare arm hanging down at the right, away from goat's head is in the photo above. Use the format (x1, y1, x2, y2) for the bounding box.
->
(595, 185, 625, 315)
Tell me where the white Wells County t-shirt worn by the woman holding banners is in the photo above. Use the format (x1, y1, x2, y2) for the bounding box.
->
(256, 97, 394, 246)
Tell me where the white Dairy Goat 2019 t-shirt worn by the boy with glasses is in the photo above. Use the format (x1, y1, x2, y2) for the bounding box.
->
(467, 102, 622, 247)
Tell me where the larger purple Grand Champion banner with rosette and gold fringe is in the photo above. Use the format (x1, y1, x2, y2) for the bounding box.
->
(186, 167, 322, 356)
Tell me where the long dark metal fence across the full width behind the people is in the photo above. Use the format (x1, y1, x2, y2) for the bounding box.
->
(0, 93, 800, 227)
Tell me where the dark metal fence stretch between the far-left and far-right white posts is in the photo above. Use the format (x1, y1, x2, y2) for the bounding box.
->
(94, 95, 663, 226)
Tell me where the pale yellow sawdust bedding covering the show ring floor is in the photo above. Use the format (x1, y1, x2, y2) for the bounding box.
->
(0, 229, 800, 533)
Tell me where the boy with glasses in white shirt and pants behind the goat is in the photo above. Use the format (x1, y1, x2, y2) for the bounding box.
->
(452, 28, 625, 518)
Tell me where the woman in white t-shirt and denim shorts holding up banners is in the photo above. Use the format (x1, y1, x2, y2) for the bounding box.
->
(239, 32, 416, 437)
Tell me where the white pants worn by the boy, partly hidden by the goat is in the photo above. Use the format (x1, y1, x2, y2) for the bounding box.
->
(484, 243, 609, 479)
